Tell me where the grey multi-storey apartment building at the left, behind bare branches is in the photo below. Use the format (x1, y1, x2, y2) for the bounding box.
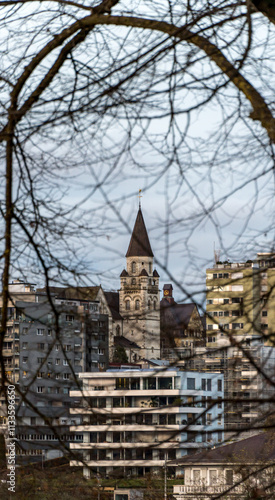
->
(0, 283, 109, 461)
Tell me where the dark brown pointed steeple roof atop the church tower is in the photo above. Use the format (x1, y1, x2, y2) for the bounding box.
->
(126, 208, 154, 257)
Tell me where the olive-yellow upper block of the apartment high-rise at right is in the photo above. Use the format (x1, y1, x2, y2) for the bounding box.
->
(206, 262, 261, 347)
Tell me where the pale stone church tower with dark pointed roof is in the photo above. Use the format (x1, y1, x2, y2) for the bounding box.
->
(119, 207, 160, 361)
